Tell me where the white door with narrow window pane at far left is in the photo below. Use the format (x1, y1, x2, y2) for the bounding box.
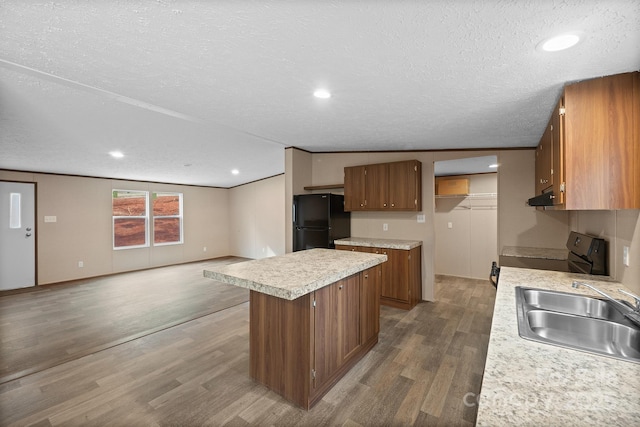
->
(0, 181, 36, 290)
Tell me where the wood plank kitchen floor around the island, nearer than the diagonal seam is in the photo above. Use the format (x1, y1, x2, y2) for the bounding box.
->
(0, 266, 495, 426)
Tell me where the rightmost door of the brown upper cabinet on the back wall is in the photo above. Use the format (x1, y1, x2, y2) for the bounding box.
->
(389, 160, 422, 211)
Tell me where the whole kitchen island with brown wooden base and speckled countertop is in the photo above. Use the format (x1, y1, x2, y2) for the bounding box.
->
(204, 249, 387, 409)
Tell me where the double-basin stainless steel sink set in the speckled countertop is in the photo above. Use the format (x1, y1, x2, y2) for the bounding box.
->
(516, 287, 640, 363)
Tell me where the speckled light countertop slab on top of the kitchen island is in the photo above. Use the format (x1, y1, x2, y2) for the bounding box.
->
(204, 249, 387, 300)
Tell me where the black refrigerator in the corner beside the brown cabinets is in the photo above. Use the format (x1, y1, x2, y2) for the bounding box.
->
(293, 193, 351, 252)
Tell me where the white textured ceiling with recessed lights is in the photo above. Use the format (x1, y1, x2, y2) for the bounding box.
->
(0, 0, 640, 187)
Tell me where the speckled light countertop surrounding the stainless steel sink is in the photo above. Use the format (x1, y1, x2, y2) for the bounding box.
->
(478, 267, 640, 426)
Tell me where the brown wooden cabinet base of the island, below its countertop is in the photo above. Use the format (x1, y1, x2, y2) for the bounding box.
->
(249, 265, 382, 409)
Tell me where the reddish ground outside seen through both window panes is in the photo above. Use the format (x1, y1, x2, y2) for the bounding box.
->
(113, 191, 180, 248)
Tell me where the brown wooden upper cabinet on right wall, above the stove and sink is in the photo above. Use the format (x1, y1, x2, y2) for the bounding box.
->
(536, 72, 640, 210)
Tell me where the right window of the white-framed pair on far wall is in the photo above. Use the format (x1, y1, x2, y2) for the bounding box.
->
(153, 193, 182, 245)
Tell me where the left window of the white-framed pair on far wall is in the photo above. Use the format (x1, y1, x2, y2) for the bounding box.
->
(112, 190, 149, 249)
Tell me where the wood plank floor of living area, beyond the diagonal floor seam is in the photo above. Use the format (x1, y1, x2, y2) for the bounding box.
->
(0, 257, 249, 383)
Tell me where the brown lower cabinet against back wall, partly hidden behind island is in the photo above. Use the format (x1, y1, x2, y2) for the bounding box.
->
(336, 244, 422, 310)
